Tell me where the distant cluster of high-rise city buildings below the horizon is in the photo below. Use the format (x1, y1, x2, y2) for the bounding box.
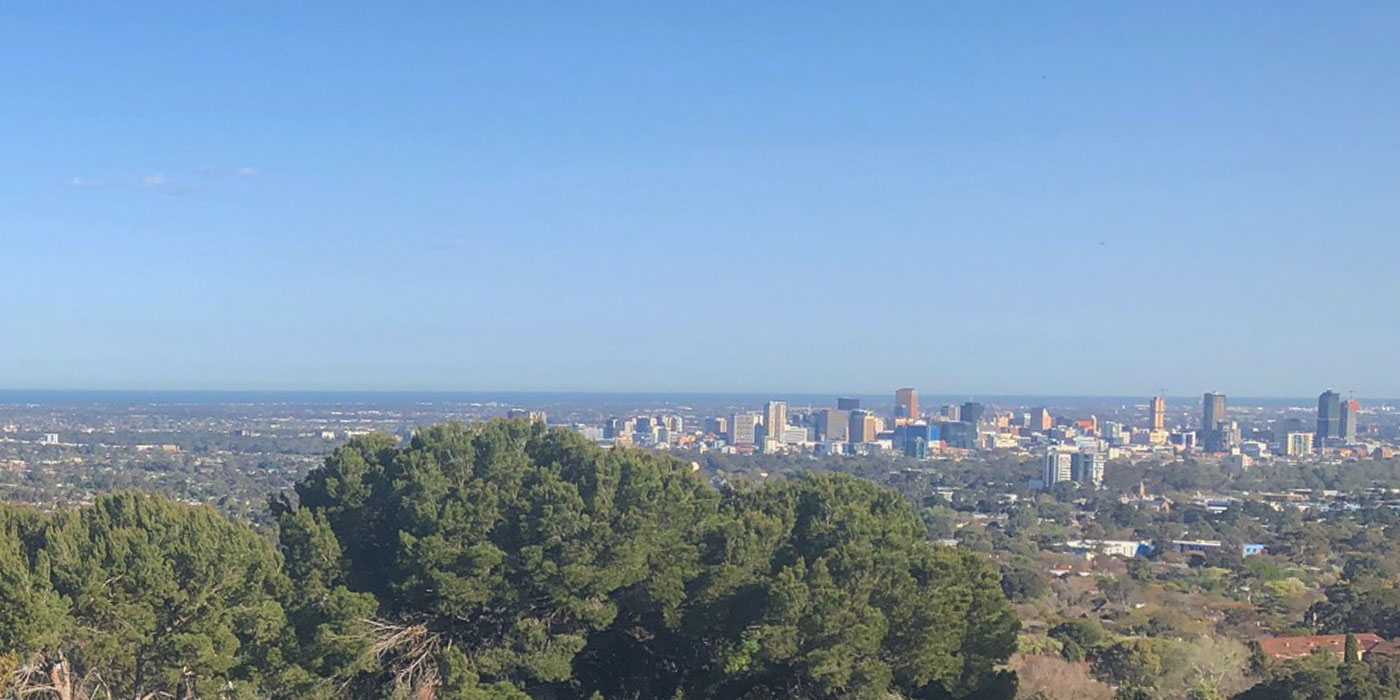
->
(560, 386, 1392, 489)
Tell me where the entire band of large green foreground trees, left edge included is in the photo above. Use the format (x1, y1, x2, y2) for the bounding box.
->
(0, 421, 1019, 700)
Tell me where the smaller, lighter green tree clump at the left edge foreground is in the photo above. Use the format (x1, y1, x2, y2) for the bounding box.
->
(0, 493, 344, 697)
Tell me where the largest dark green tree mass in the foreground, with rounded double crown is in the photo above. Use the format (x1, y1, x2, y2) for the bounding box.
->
(292, 421, 1018, 700)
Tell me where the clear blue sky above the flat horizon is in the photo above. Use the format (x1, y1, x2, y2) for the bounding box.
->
(0, 0, 1400, 396)
